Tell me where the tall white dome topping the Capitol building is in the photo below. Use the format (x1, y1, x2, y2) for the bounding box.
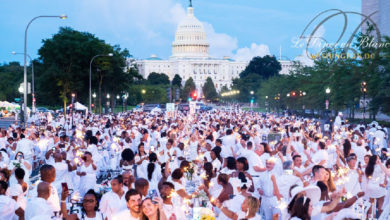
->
(172, 7, 209, 58)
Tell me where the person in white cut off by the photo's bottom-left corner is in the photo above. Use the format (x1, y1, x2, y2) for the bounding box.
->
(0, 180, 24, 220)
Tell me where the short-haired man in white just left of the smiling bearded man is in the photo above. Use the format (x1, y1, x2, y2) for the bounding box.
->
(100, 175, 126, 220)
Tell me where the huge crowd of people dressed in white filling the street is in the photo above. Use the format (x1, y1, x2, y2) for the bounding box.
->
(0, 111, 390, 220)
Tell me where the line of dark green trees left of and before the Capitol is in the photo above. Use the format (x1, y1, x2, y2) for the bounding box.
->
(0, 27, 217, 111)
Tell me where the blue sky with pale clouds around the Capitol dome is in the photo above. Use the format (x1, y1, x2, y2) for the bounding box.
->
(0, 0, 361, 63)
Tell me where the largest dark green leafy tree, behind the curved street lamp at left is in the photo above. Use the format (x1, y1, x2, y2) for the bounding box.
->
(36, 28, 134, 111)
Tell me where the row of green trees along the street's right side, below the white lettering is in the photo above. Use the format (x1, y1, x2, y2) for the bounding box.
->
(256, 31, 390, 117)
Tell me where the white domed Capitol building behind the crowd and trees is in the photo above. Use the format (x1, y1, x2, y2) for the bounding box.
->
(134, 5, 292, 92)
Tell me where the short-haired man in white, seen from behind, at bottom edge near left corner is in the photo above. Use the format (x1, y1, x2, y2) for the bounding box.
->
(24, 182, 53, 220)
